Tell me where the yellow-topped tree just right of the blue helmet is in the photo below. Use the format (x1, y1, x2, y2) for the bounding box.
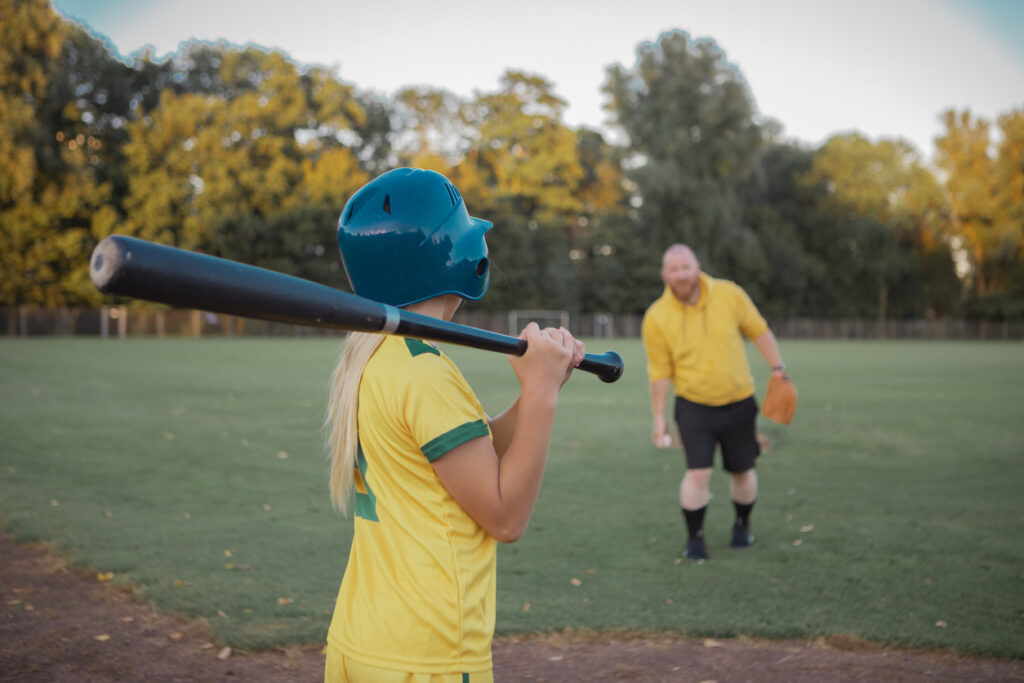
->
(462, 71, 584, 310)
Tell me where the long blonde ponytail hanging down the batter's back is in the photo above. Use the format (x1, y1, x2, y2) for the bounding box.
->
(324, 332, 384, 514)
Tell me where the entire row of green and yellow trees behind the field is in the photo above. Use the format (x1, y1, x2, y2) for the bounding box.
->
(0, 0, 1024, 319)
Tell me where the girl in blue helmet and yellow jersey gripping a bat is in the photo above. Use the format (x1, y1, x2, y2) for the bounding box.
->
(325, 169, 584, 683)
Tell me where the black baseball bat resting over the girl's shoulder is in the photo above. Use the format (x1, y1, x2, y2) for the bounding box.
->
(89, 234, 623, 382)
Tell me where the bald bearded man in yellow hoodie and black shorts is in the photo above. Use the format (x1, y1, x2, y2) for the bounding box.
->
(642, 244, 785, 562)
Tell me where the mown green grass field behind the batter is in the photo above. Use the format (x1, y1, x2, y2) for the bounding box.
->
(0, 339, 1024, 657)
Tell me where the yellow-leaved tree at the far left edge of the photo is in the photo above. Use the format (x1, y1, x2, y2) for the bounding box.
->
(0, 0, 116, 306)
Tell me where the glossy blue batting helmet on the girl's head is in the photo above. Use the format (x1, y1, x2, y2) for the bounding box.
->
(338, 168, 492, 306)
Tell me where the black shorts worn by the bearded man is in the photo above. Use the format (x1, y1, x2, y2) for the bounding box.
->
(676, 396, 761, 473)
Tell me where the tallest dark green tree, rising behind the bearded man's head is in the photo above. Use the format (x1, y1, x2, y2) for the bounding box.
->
(604, 32, 767, 284)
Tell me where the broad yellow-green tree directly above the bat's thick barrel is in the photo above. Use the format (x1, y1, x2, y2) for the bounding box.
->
(121, 44, 387, 276)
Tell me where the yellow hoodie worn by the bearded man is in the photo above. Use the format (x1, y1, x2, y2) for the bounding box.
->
(641, 272, 768, 405)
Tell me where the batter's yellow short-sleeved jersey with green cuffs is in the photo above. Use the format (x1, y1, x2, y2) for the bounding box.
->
(328, 336, 497, 674)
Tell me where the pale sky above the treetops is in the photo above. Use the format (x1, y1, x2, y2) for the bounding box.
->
(54, 0, 1024, 158)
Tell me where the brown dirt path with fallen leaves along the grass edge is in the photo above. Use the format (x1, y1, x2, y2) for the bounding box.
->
(0, 533, 1024, 683)
